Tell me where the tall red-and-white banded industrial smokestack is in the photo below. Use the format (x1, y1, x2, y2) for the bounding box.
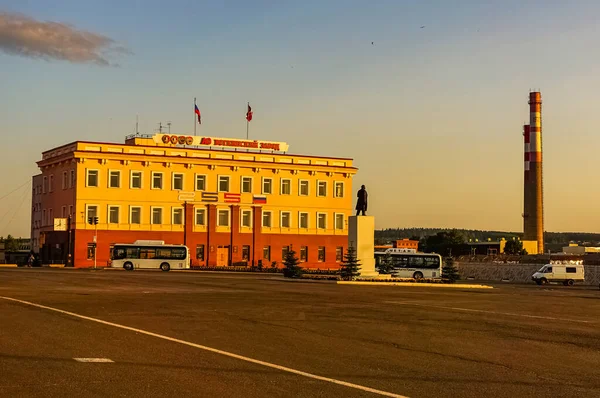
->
(523, 92, 544, 253)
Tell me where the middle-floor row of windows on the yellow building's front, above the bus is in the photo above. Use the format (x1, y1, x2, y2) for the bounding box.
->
(84, 205, 345, 230)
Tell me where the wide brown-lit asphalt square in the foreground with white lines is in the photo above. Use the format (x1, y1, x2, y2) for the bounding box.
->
(0, 268, 600, 398)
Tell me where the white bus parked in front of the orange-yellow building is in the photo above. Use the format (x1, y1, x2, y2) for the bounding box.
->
(111, 240, 190, 271)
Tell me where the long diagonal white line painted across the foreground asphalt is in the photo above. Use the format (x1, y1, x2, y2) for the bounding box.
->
(0, 296, 408, 398)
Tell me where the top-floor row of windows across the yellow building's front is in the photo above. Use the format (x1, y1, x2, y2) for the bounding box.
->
(86, 169, 344, 198)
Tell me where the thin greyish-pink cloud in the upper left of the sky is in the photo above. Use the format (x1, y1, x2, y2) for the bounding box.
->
(0, 12, 131, 66)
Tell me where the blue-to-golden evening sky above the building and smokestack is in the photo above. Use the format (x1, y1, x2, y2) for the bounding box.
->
(0, 0, 600, 236)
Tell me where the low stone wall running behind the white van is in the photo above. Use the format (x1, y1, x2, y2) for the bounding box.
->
(455, 262, 600, 286)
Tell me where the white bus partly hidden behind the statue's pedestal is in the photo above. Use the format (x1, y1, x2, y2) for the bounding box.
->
(375, 248, 442, 279)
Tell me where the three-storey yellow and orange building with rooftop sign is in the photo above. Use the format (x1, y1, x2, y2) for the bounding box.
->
(32, 134, 357, 268)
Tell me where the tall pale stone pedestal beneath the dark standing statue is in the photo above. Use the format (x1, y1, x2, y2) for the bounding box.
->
(348, 216, 379, 278)
